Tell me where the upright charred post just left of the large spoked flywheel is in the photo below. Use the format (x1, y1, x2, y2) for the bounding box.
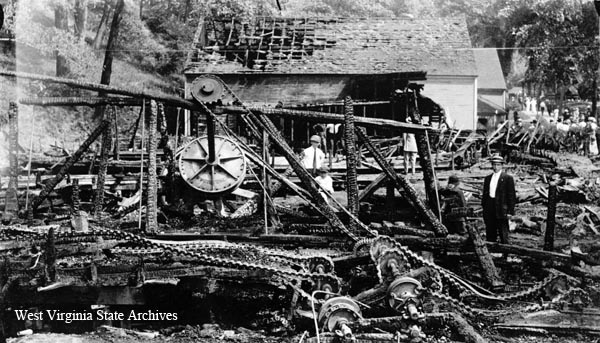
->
(146, 100, 158, 234)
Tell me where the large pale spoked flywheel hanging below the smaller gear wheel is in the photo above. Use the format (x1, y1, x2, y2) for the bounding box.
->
(179, 136, 246, 195)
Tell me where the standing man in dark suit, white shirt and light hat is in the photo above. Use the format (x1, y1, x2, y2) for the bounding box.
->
(481, 154, 517, 244)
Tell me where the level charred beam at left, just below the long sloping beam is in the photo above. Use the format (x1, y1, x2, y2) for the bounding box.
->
(19, 96, 143, 107)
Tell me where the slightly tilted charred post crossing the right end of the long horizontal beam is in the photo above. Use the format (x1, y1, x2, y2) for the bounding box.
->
(408, 90, 440, 217)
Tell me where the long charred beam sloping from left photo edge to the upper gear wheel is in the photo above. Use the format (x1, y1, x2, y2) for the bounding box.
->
(0, 70, 192, 110)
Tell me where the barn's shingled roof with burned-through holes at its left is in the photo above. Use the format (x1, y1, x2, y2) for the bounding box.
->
(184, 17, 477, 76)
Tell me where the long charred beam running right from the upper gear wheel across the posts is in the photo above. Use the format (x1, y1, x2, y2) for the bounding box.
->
(218, 106, 436, 133)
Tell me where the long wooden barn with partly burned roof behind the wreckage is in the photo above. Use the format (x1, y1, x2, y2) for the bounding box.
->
(184, 17, 477, 145)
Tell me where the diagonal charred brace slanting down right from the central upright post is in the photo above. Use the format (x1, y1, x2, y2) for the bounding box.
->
(356, 128, 448, 236)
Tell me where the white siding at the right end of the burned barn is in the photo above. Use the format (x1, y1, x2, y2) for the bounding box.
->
(423, 75, 477, 130)
